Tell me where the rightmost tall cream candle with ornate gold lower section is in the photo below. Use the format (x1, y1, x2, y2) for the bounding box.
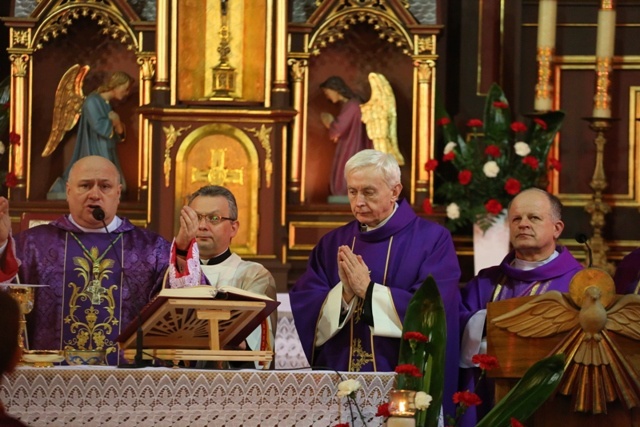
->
(593, 0, 616, 118)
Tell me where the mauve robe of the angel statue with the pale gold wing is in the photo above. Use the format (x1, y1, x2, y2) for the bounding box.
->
(329, 98, 373, 196)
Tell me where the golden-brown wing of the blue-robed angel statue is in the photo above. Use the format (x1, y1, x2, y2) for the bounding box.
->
(42, 64, 90, 157)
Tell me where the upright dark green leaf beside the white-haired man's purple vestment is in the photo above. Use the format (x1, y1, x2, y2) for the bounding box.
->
(397, 276, 447, 427)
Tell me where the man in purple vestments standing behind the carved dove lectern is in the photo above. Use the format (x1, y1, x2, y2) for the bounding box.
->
(460, 188, 583, 426)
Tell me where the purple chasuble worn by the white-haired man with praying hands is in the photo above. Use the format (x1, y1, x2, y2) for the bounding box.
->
(289, 200, 460, 418)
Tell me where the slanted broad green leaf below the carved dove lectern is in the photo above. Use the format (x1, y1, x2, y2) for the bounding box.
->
(476, 354, 564, 427)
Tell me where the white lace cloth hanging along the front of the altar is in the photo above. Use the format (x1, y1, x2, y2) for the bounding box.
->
(0, 367, 395, 427)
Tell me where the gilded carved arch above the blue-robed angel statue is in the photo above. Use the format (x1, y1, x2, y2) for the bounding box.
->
(29, 0, 139, 52)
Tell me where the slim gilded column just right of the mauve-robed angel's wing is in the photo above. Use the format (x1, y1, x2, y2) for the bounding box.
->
(411, 59, 436, 204)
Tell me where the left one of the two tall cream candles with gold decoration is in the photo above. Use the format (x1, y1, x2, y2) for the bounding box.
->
(534, 0, 558, 111)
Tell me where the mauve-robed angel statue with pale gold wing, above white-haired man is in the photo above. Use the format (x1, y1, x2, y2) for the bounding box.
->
(320, 73, 404, 196)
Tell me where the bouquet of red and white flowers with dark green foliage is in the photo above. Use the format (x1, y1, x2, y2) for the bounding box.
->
(425, 84, 564, 231)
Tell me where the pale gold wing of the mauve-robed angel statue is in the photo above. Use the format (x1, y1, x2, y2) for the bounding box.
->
(360, 73, 404, 166)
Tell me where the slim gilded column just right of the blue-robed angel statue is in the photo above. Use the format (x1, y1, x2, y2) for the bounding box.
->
(137, 52, 156, 200)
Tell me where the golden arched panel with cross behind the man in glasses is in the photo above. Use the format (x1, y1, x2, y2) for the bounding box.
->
(174, 123, 260, 255)
